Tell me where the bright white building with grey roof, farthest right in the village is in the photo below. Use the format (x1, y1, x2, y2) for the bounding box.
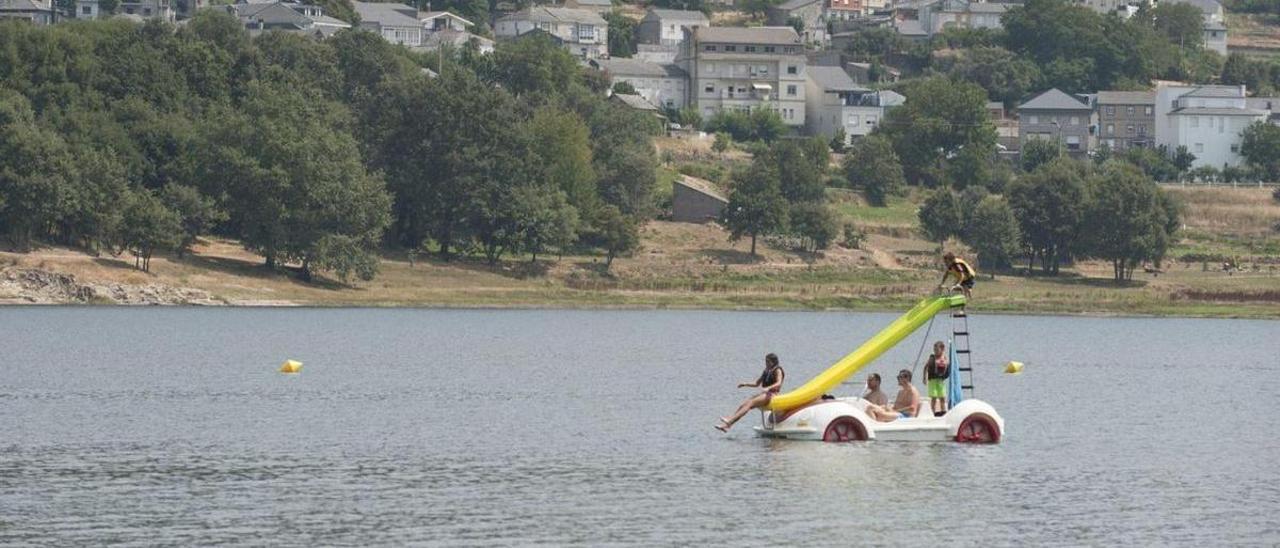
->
(1156, 86, 1271, 169)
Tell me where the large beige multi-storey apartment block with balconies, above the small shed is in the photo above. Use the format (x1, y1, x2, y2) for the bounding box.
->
(676, 27, 805, 128)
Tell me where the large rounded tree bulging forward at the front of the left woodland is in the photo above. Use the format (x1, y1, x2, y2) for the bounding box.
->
(198, 82, 390, 280)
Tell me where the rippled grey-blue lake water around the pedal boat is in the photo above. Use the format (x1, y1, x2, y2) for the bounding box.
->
(0, 307, 1280, 545)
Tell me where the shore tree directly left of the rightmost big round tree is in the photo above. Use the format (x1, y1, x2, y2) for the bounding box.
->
(1009, 157, 1087, 275)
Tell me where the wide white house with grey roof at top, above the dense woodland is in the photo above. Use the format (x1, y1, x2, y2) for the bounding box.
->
(494, 6, 609, 59)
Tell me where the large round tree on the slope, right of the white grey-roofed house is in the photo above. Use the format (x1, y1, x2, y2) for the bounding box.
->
(881, 77, 996, 183)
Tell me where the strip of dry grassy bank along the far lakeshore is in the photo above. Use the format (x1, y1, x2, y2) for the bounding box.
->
(0, 188, 1280, 318)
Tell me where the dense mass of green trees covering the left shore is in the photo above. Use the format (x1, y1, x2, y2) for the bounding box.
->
(0, 10, 660, 280)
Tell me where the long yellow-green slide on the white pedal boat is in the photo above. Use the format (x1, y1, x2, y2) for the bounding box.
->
(769, 294, 964, 411)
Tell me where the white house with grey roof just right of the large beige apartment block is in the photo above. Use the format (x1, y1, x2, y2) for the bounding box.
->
(805, 67, 905, 145)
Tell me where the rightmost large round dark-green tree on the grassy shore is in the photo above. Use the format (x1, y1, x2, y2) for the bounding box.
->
(1082, 163, 1176, 282)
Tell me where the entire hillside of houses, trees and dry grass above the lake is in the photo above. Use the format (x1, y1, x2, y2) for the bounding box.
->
(0, 0, 1280, 314)
